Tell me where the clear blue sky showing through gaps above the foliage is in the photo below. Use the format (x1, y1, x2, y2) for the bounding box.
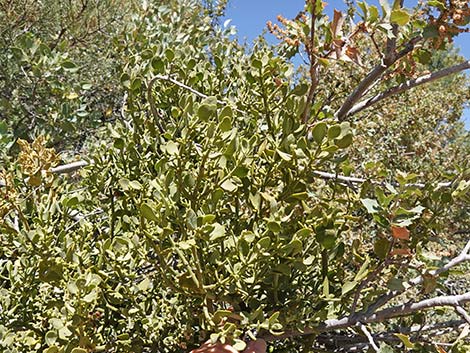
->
(226, 0, 470, 130)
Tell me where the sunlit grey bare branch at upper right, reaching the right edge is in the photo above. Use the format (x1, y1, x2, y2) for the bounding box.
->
(348, 60, 470, 115)
